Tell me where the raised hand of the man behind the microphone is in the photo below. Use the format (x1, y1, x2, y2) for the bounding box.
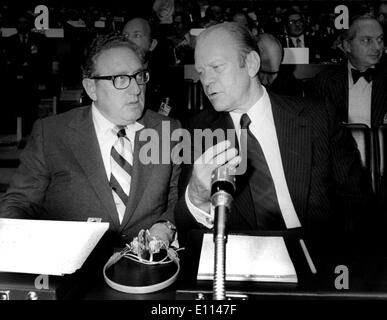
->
(188, 140, 241, 212)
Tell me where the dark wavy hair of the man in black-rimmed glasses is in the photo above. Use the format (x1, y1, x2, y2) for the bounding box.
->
(82, 33, 144, 78)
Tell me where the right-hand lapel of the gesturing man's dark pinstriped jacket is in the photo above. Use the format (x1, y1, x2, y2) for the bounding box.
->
(270, 94, 312, 224)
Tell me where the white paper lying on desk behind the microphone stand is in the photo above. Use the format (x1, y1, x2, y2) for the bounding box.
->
(197, 233, 297, 283)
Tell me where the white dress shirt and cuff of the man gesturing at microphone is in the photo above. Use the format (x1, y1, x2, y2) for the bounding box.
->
(185, 87, 301, 229)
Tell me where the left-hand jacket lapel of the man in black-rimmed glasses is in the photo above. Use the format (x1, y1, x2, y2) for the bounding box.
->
(67, 107, 119, 229)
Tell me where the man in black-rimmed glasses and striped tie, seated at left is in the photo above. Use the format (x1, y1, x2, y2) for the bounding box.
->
(0, 35, 180, 255)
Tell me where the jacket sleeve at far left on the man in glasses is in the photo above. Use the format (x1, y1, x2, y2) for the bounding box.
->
(0, 120, 50, 219)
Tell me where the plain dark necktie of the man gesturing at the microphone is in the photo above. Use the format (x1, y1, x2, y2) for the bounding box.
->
(240, 114, 286, 230)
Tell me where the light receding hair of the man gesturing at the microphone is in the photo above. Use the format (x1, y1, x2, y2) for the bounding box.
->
(199, 22, 258, 67)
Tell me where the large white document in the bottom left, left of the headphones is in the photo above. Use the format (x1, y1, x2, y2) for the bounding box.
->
(0, 219, 109, 275)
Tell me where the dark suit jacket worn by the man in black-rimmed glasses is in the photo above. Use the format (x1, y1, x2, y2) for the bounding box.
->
(0, 107, 180, 245)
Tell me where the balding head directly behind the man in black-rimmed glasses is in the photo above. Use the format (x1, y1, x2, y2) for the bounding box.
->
(122, 18, 157, 52)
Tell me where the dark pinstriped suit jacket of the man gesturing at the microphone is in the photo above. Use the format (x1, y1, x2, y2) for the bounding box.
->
(175, 93, 372, 251)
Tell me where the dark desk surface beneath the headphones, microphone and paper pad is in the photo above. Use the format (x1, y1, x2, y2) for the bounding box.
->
(84, 233, 387, 300)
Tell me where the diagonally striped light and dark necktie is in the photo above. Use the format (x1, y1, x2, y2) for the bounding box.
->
(110, 127, 133, 223)
